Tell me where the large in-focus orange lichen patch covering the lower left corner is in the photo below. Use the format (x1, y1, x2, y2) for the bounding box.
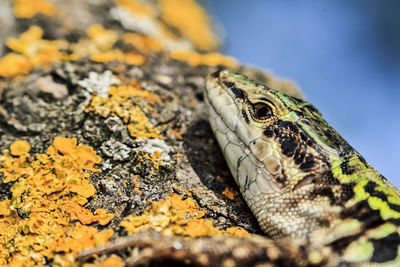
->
(0, 137, 114, 266)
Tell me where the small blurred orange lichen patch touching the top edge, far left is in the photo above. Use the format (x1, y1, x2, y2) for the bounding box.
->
(13, 0, 56, 19)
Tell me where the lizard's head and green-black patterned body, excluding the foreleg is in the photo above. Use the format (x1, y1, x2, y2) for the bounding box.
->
(205, 71, 400, 265)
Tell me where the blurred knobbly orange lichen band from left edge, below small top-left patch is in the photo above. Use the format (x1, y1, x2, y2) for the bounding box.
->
(0, 24, 147, 77)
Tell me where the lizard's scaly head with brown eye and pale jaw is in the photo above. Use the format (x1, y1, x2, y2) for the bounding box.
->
(204, 70, 352, 240)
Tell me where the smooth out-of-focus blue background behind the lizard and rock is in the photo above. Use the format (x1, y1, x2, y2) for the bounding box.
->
(205, 0, 400, 188)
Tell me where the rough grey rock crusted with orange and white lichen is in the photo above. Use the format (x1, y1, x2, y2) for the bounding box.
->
(0, 0, 298, 266)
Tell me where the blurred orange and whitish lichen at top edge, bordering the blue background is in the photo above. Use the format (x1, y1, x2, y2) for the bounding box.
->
(115, 0, 219, 55)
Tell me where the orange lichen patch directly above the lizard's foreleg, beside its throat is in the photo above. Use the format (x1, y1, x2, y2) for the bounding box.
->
(121, 194, 250, 237)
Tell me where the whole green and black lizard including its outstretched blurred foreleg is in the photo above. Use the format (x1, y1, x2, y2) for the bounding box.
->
(80, 70, 400, 266)
